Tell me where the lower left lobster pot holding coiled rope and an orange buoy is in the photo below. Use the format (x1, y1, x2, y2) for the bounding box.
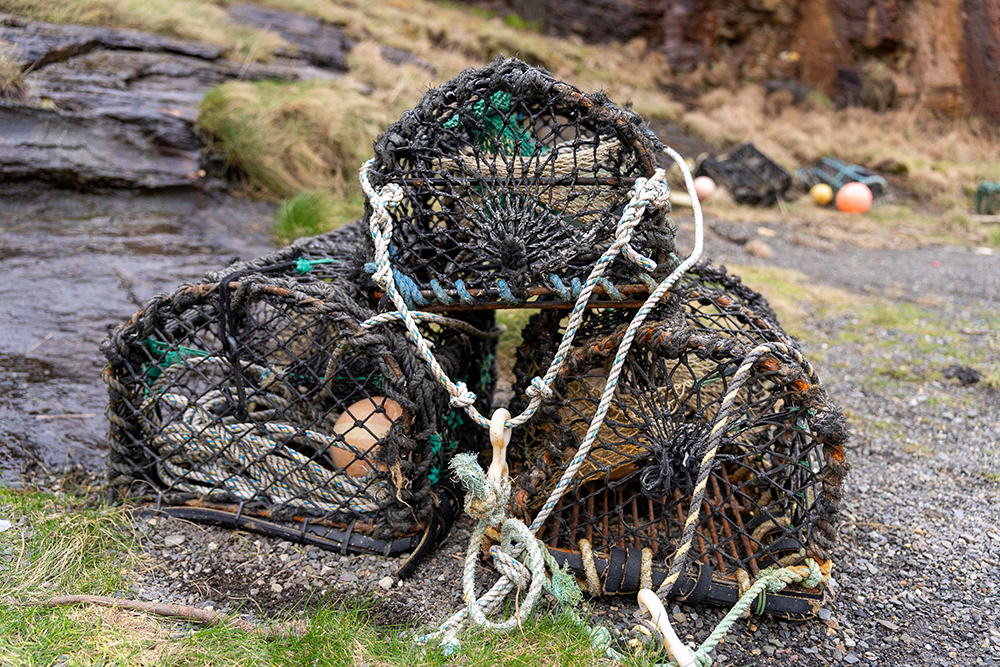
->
(103, 239, 494, 554)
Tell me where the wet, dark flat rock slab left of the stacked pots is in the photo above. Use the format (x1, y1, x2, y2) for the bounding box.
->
(0, 183, 272, 483)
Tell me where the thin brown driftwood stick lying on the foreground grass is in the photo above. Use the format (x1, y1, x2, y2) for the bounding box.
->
(24, 595, 308, 640)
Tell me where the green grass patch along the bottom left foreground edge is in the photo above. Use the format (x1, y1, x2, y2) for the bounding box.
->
(0, 489, 616, 667)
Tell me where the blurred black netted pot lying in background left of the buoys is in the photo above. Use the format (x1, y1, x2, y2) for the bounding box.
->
(695, 143, 792, 206)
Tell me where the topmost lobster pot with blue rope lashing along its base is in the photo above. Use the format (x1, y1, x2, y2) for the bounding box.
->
(366, 59, 677, 309)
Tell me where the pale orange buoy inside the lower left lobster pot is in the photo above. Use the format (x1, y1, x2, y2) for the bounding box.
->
(330, 396, 403, 477)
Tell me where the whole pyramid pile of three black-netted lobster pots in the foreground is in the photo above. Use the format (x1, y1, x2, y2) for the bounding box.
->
(105, 59, 846, 604)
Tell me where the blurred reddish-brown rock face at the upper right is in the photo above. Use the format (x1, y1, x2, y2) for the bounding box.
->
(492, 0, 1000, 118)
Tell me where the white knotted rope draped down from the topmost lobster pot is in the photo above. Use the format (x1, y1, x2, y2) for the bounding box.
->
(360, 148, 704, 650)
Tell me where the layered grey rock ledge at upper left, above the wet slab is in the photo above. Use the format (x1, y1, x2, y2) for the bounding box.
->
(0, 12, 343, 188)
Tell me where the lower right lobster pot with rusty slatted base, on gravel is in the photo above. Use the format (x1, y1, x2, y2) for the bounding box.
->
(510, 265, 847, 618)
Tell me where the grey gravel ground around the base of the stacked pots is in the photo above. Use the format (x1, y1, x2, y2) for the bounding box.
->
(121, 218, 1000, 666)
